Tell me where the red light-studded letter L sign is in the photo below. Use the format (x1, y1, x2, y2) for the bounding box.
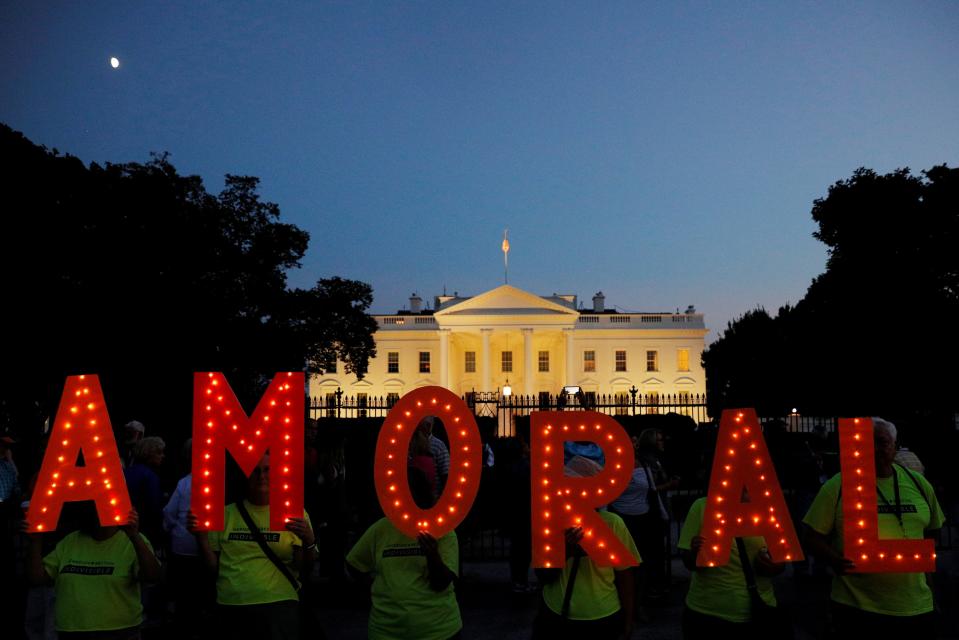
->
(839, 418, 936, 573)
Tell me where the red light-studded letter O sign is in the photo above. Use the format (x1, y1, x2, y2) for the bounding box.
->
(373, 387, 483, 538)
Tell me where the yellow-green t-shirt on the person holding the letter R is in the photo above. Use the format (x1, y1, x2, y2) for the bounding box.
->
(543, 511, 642, 620)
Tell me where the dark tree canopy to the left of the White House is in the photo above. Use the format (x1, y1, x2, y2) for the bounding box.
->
(0, 125, 375, 444)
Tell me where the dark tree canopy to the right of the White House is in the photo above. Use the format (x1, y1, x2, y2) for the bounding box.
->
(703, 165, 959, 415)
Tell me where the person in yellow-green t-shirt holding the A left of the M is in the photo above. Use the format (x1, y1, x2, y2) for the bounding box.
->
(27, 502, 160, 640)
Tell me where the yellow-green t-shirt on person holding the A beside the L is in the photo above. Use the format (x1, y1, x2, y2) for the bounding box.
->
(676, 498, 776, 622)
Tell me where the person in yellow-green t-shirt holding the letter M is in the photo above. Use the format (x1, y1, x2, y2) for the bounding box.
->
(187, 455, 316, 640)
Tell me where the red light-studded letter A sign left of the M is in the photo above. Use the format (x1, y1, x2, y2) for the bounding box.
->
(27, 375, 133, 531)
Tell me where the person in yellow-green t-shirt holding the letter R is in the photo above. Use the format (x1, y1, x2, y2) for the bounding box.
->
(533, 456, 642, 640)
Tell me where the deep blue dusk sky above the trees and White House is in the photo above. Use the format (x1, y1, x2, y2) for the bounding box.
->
(0, 1, 959, 338)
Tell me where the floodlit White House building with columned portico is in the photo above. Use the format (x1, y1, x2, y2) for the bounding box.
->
(310, 285, 707, 404)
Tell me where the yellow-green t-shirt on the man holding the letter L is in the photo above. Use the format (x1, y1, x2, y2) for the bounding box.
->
(803, 465, 945, 616)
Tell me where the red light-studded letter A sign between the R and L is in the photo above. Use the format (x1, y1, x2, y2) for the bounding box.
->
(696, 409, 803, 567)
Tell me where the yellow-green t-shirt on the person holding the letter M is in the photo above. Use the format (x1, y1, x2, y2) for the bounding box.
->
(210, 500, 310, 605)
